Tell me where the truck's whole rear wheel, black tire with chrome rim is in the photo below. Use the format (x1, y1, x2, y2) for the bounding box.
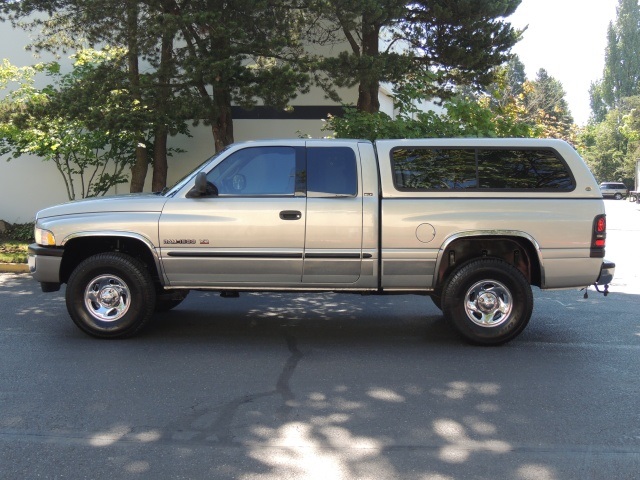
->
(442, 258, 533, 345)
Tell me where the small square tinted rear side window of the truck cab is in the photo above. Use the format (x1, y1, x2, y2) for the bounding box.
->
(307, 147, 358, 197)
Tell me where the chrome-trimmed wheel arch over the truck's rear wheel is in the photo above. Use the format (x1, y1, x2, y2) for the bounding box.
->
(434, 230, 544, 289)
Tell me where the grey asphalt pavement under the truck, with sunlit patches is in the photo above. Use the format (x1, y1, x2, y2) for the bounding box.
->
(0, 200, 640, 480)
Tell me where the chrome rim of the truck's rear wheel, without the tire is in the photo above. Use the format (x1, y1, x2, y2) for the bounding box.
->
(464, 280, 513, 327)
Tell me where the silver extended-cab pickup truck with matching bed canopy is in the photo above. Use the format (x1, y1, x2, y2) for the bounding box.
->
(29, 139, 615, 345)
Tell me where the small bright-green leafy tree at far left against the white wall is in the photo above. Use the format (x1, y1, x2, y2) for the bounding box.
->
(0, 59, 135, 200)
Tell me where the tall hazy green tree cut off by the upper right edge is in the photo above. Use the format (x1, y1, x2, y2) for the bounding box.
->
(590, 0, 640, 122)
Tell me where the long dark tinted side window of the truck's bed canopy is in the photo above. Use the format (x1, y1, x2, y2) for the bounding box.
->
(391, 148, 574, 191)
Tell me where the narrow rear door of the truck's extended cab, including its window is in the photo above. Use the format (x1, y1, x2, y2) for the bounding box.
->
(302, 141, 363, 284)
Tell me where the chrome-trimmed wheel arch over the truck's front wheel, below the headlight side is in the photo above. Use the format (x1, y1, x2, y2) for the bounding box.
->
(60, 232, 165, 284)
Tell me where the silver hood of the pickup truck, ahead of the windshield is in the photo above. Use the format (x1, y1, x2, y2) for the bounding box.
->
(37, 193, 167, 219)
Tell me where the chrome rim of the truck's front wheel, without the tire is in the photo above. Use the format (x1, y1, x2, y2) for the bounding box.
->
(84, 275, 131, 322)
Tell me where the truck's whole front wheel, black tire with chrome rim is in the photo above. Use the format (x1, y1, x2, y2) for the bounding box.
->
(65, 252, 156, 338)
